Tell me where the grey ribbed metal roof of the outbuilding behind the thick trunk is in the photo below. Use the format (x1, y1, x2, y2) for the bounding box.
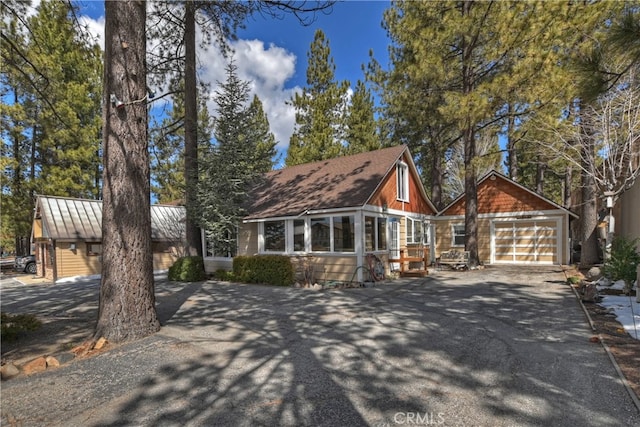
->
(35, 196, 186, 241)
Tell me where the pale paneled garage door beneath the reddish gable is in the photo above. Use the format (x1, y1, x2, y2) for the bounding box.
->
(491, 220, 560, 264)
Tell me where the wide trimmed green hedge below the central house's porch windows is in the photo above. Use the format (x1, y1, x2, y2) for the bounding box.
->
(233, 255, 295, 286)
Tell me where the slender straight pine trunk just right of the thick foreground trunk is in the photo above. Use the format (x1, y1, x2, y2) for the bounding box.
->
(184, 1, 202, 255)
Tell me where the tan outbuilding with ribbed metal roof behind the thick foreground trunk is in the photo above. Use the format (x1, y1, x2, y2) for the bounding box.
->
(31, 196, 185, 282)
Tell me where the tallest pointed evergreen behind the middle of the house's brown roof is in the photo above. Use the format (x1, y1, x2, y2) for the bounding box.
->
(285, 30, 349, 166)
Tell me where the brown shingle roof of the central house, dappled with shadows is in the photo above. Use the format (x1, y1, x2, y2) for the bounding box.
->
(245, 145, 407, 220)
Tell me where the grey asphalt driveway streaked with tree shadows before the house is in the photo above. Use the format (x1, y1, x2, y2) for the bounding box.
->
(2, 267, 640, 427)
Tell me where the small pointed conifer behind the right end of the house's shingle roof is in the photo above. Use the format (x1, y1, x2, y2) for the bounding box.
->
(345, 80, 381, 154)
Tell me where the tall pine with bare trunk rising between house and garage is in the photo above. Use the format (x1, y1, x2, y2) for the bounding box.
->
(385, 1, 606, 264)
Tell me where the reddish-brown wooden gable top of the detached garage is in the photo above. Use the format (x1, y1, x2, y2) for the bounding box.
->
(438, 170, 578, 218)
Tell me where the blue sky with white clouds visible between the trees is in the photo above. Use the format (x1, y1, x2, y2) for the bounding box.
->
(69, 0, 390, 152)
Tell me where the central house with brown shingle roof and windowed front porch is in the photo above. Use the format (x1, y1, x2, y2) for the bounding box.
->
(216, 145, 436, 282)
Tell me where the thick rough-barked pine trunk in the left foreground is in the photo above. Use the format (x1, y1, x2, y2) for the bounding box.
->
(95, 1, 160, 342)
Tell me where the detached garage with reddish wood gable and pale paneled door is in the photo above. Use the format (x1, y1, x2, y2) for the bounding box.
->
(435, 171, 577, 264)
